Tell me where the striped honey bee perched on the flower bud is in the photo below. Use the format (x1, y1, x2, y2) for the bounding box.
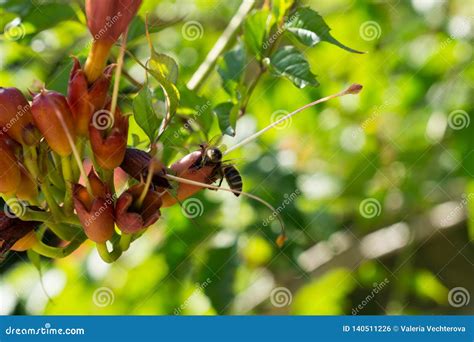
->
(192, 144, 242, 197)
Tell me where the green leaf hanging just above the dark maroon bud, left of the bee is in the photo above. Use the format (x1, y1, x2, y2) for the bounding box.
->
(133, 85, 161, 141)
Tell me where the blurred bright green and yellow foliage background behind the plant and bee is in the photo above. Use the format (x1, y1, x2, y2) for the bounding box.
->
(0, 0, 474, 315)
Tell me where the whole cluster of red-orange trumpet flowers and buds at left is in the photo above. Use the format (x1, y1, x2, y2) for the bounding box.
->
(0, 0, 292, 262)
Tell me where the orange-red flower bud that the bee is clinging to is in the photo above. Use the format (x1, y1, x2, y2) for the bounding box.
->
(162, 151, 215, 208)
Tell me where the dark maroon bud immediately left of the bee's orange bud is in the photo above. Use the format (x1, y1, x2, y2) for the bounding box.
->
(120, 147, 171, 189)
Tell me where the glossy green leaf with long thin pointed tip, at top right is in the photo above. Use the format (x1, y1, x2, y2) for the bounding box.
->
(284, 7, 363, 53)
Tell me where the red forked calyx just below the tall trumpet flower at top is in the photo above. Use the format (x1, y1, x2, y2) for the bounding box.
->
(67, 58, 115, 136)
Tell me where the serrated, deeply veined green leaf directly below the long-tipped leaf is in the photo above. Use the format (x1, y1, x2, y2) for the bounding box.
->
(270, 46, 319, 88)
